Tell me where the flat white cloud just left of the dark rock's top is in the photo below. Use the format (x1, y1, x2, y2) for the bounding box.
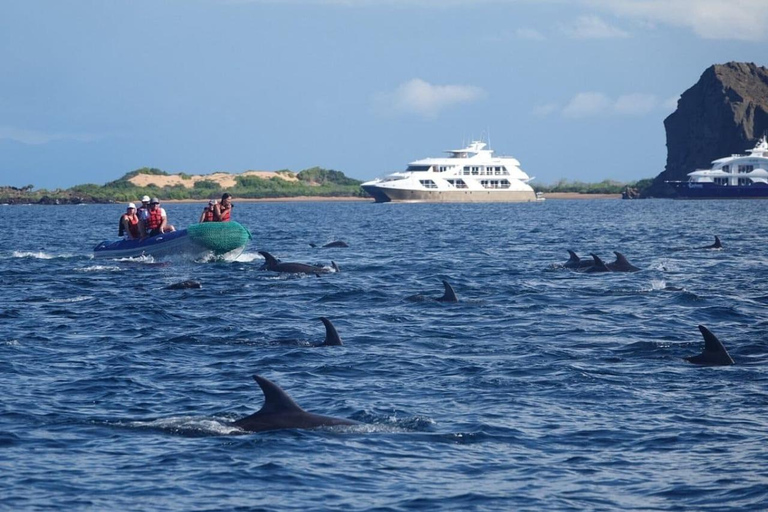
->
(560, 92, 669, 119)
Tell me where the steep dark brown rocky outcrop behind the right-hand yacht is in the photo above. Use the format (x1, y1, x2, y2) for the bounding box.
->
(643, 62, 768, 197)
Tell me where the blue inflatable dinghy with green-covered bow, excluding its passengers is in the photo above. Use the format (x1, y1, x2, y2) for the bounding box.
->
(93, 222, 252, 259)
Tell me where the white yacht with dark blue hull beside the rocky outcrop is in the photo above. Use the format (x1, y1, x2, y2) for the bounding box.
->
(667, 136, 768, 199)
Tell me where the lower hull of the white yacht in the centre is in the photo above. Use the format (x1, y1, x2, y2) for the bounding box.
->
(362, 185, 537, 203)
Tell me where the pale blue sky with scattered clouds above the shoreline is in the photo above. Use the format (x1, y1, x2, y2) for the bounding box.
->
(0, 0, 768, 189)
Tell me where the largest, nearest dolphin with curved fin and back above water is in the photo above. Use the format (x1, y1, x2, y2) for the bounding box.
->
(234, 375, 359, 432)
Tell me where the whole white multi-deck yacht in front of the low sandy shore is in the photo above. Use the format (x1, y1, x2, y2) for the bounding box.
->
(361, 141, 541, 203)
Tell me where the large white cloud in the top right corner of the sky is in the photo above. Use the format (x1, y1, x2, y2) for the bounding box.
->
(586, 0, 768, 41)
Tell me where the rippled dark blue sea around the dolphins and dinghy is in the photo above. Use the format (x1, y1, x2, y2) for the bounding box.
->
(0, 200, 768, 511)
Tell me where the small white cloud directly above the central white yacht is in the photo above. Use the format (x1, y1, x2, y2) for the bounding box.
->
(374, 78, 486, 117)
